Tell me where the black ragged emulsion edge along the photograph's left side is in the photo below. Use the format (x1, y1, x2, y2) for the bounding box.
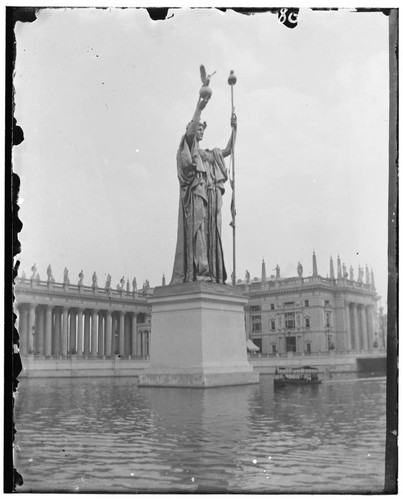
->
(3, 7, 37, 493)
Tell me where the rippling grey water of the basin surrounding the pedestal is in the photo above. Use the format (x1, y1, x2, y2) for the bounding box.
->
(15, 374, 386, 493)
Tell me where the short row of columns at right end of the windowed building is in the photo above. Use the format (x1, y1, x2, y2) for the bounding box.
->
(346, 302, 374, 351)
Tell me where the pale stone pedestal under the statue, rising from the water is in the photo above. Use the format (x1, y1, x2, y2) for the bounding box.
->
(139, 282, 259, 387)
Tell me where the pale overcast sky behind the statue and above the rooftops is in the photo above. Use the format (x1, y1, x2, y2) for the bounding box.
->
(13, 8, 389, 306)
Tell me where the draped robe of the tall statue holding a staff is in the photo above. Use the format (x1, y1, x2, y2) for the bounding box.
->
(171, 130, 228, 284)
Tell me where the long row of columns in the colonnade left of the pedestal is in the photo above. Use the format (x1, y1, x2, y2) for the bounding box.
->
(18, 304, 150, 357)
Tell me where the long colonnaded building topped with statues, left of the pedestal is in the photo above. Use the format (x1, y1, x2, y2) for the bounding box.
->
(14, 270, 151, 358)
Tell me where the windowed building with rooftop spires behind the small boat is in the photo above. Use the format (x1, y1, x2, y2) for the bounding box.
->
(237, 253, 385, 356)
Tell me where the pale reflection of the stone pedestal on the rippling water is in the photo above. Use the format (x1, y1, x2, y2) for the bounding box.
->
(141, 386, 255, 492)
